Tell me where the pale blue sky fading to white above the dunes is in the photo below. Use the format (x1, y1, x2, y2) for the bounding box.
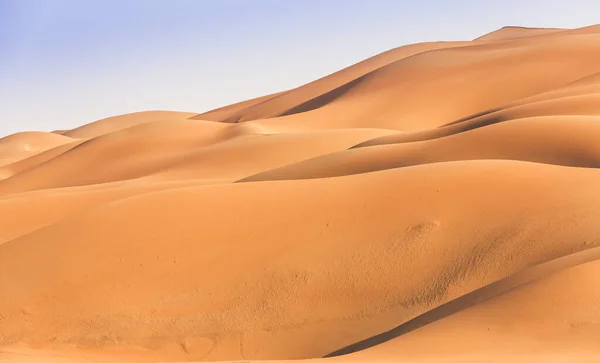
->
(0, 0, 600, 137)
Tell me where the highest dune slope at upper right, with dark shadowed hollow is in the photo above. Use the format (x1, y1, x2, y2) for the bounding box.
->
(198, 25, 600, 131)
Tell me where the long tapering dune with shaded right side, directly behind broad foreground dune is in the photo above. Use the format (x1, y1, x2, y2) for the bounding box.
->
(240, 116, 600, 182)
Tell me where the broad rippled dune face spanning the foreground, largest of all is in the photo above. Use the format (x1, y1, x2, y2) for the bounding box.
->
(0, 161, 600, 359)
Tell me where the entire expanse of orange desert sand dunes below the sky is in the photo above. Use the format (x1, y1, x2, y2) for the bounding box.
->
(0, 26, 600, 363)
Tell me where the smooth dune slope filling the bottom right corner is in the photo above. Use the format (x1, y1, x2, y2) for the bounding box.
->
(337, 249, 600, 362)
